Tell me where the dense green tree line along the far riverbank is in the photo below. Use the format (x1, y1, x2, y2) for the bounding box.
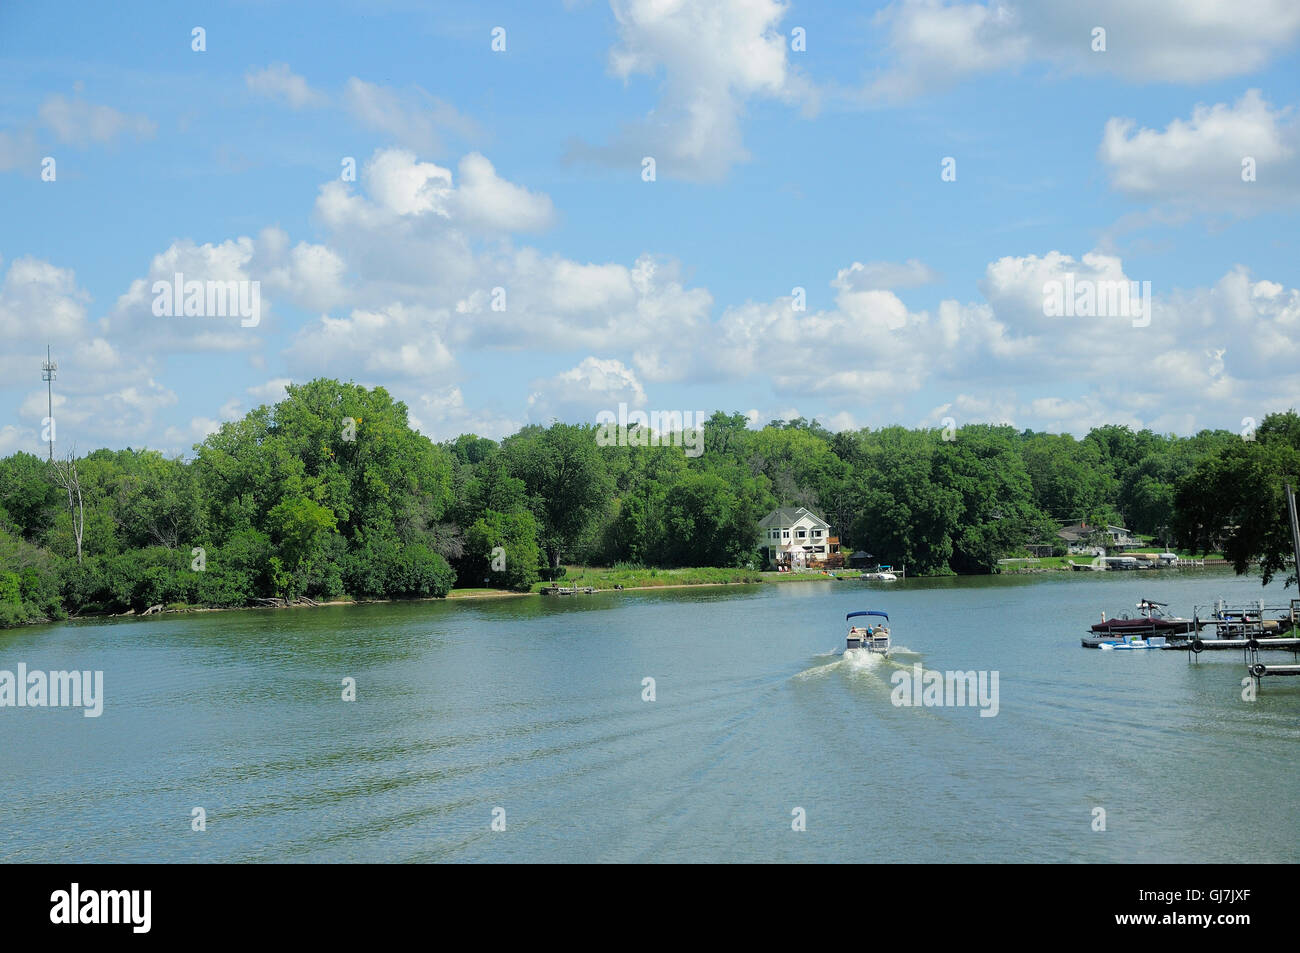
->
(0, 380, 1300, 625)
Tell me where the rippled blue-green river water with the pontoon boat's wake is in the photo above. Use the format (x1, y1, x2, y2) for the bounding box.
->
(0, 569, 1300, 862)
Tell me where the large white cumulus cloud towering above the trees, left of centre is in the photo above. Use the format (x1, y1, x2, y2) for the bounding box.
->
(294, 150, 712, 380)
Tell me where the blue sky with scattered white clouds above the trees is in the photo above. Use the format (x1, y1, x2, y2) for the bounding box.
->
(0, 0, 1300, 454)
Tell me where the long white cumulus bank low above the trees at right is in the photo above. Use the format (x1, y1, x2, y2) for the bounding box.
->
(707, 251, 1300, 433)
